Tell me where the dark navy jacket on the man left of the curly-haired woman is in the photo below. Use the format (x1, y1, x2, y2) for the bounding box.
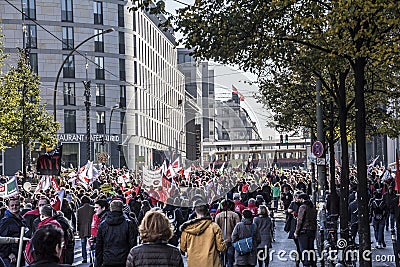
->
(96, 211, 137, 266)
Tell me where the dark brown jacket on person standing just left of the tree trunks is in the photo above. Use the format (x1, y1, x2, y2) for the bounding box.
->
(295, 200, 317, 235)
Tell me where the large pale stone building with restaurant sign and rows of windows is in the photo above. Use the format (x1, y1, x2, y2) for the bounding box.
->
(0, 0, 185, 174)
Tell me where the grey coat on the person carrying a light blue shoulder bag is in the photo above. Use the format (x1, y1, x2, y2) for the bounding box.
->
(232, 219, 261, 265)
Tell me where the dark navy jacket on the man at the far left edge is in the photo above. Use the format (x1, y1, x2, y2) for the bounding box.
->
(0, 210, 29, 258)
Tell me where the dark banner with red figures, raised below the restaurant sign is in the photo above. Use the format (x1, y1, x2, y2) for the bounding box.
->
(36, 145, 62, 175)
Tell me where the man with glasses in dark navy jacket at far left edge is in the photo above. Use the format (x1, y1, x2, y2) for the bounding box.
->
(0, 197, 28, 267)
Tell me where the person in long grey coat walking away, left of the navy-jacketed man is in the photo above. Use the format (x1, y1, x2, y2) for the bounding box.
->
(76, 196, 94, 263)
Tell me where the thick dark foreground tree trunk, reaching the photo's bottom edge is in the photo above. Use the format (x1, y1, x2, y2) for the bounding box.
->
(353, 58, 372, 267)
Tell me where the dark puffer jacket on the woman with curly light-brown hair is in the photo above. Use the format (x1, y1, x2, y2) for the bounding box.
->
(126, 240, 183, 267)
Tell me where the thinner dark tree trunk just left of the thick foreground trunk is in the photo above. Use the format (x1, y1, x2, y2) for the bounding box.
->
(338, 72, 349, 243)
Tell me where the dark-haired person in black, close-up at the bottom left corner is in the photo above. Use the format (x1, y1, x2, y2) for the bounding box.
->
(30, 224, 72, 267)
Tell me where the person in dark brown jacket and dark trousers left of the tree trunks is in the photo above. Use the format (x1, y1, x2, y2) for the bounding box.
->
(294, 193, 317, 267)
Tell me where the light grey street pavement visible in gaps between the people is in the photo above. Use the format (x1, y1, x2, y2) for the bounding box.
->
(74, 212, 396, 267)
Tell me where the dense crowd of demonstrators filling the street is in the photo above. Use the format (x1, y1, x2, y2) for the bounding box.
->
(0, 162, 398, 267)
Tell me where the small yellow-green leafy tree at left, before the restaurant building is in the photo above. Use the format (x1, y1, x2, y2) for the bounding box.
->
(0, 50, 60, 181)
